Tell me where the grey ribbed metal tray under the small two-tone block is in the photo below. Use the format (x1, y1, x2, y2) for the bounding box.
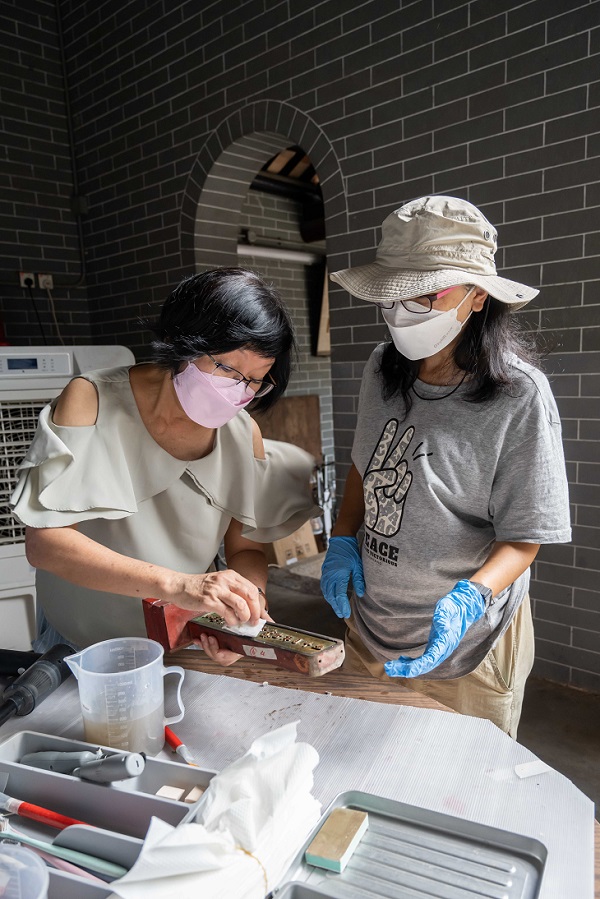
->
(271, 791, 548, 899)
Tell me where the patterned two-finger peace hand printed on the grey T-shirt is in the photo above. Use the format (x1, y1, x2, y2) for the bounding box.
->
(363, 419, 415, 537)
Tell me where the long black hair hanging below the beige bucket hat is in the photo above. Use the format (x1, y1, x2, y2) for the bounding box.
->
(379, 296, 540, 418)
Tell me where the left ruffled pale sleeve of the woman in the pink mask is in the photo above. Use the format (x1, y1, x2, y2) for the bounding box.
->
(11, 405, 137, 528)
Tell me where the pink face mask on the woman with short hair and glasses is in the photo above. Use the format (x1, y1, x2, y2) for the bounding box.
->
(173, 362, 254, 428)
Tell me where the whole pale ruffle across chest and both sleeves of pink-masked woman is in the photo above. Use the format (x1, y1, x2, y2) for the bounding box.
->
(11, 402, 321, 543)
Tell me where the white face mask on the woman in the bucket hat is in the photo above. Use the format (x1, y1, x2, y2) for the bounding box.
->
(382, 287, 475, 361)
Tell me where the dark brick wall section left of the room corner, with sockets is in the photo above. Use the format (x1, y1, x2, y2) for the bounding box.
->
(0, 0, 91, 344)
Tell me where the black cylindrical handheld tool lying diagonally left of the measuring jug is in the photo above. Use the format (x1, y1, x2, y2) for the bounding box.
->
(0, 643, 74, 726)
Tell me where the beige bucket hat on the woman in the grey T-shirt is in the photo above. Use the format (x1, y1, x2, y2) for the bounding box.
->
(330, 196, 539, 309)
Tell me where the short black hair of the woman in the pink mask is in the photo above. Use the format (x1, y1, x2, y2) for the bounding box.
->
(151, 268, 297, 412)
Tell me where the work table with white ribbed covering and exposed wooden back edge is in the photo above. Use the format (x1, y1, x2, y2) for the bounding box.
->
(0, 650, 594, 899)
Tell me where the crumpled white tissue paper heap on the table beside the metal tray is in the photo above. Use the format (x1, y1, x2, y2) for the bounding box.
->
(110, 721, 321, 899)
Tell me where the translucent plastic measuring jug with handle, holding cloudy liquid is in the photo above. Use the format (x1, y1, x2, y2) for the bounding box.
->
(65, 637, 184, 755)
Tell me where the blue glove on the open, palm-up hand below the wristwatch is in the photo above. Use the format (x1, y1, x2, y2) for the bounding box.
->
(384, 580, 485, 677)
